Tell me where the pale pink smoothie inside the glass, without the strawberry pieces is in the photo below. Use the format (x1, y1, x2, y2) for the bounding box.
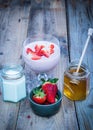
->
(23, 41, 60, 73)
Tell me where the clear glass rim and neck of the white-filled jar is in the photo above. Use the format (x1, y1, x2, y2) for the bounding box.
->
(1, 64, 23, 79)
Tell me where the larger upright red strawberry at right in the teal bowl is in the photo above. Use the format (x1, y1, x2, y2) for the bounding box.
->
(42, 79, 58, 103)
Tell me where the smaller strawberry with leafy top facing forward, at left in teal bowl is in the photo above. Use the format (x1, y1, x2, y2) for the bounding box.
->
(32, 88, 46, 104)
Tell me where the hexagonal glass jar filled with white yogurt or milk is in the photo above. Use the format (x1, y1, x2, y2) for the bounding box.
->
(1, 65, 26, 102)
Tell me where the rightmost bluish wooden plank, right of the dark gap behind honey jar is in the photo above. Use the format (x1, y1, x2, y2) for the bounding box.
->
(67, 0, 93, 130)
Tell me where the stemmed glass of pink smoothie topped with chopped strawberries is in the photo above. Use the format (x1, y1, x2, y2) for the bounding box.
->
(22, 34, 60, 80)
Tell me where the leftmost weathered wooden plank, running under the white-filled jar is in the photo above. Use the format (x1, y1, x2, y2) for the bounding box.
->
(0, 0, 29, 130)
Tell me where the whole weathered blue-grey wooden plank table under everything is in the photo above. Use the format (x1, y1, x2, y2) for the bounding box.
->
(0, 0, 93, 130)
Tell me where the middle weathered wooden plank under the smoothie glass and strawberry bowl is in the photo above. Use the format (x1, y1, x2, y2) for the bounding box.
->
(17, 0, 78, 130)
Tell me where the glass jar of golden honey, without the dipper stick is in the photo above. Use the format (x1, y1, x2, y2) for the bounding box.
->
(63, 61, 90, 100)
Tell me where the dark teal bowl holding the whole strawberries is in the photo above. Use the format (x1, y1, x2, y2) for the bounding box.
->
(29, 87, 62, 117)
